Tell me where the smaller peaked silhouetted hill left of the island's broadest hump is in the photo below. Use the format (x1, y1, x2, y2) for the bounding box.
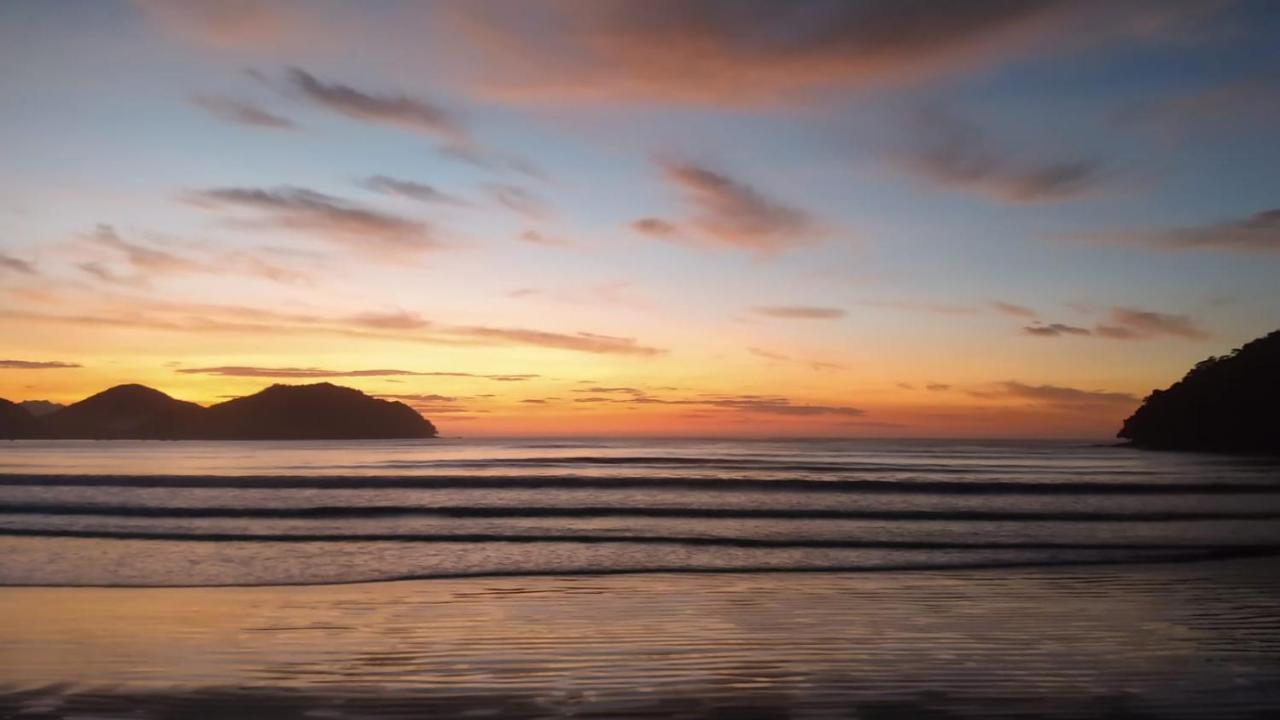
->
(42, 384, 205, 439)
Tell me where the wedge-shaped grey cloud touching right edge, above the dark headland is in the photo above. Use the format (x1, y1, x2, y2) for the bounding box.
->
(1076, 208, 1280, 252)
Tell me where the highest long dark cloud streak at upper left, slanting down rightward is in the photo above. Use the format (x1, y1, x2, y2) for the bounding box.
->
(277, 68, 471, 146)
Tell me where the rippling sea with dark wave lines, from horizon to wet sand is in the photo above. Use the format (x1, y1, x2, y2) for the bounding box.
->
(0, 439, 1280, 585)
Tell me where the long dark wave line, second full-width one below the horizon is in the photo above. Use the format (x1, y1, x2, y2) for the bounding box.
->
(10, 502, 1280, 523)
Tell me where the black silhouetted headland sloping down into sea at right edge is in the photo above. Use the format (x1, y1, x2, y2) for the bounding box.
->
(1116, 331, 1280, 454)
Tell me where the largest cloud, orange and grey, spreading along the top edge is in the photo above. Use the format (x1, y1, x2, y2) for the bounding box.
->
(449, 0, 1208, 106)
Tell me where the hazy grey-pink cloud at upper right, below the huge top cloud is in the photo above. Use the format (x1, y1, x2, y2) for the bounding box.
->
(896, 109, 1108, 204)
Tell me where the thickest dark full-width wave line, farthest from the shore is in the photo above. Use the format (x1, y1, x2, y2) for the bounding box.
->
(0, 474, 1280, 495)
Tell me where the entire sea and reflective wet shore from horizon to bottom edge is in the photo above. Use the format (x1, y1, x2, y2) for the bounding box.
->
(0, 438, 1280, 717)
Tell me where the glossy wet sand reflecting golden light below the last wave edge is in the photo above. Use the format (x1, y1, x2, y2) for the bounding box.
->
(0, 559, 1280, 719)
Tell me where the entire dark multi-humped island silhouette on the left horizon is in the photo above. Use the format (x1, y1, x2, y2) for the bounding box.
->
(0, 383, 438, 439)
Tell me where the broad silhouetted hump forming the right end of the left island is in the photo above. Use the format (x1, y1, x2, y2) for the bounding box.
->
(205, 383, 436, 439)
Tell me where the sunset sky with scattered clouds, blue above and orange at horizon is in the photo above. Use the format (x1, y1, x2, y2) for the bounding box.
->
(0, 0, 1280, 438)
